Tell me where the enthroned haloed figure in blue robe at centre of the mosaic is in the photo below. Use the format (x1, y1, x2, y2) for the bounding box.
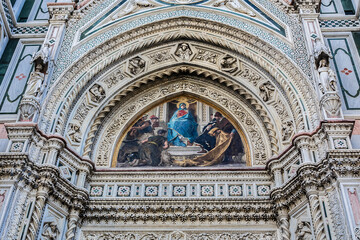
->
(168, 103, 198, 147)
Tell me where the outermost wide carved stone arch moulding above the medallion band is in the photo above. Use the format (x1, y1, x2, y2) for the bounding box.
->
(40, 18, 318, 139)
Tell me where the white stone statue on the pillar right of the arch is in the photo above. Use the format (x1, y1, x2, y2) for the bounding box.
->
(317, 58, 337, 94)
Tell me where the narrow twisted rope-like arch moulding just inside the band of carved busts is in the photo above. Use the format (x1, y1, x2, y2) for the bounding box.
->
(83, 64, 279, 161)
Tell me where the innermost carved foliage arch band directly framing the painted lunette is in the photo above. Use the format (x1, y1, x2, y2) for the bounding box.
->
(93, 79, 273, 167)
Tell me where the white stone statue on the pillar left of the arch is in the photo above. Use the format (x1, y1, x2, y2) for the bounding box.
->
(24, 64, 46, 98)
